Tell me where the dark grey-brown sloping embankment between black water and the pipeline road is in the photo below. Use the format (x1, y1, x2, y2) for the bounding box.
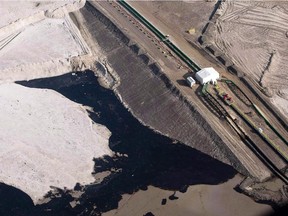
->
(75, 4, 258, 175)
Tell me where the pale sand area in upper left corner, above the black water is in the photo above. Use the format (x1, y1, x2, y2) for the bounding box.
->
(0, 0, 90, 83)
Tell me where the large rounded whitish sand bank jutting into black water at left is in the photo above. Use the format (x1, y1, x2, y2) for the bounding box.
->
(0, 84, 112, 202)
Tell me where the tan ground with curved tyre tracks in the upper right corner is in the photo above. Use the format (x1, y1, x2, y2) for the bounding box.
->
(205, 1, 288, 119)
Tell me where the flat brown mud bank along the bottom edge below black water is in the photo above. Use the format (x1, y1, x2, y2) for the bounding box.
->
(103, 175, 272, 216)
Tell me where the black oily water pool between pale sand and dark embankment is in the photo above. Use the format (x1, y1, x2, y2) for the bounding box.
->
(4, 71, 236, 215)
